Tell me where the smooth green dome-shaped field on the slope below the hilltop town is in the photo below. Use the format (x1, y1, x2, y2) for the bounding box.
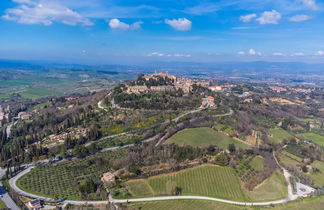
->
(167, 127, 249, 149)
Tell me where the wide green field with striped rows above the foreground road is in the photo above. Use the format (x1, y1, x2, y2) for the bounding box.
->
(126, 164, 246, 201)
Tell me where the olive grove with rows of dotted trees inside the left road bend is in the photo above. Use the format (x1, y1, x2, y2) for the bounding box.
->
(17, 151, 123, 200)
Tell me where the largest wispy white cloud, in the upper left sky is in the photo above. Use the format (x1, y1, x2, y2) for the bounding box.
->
(2, 0, 93, 26)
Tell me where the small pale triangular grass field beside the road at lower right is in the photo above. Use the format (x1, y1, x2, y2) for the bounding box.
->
(246, 171, 288, 201)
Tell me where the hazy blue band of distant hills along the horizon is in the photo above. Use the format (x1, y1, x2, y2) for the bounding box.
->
(0, 60, 324, 74)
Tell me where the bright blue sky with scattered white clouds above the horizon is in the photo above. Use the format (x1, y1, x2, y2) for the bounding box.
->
(0, 0, 324, 64)
